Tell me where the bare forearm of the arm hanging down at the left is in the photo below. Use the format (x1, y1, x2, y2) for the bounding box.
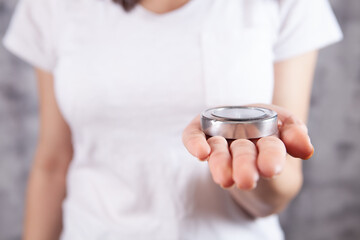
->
(23, 158, 65, 240)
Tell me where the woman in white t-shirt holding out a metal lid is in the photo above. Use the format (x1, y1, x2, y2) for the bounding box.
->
(4, 0, 341, 240)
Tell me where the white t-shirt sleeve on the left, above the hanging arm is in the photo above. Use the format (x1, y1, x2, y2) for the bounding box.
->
(3, 0, 56, 72)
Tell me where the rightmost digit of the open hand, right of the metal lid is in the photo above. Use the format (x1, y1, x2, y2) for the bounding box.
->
(279, 116, 314, 159)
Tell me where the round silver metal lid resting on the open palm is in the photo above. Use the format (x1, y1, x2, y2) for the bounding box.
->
(201, 106, 278, 139)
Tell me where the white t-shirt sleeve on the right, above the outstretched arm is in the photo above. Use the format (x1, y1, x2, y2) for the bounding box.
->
(274, 0, 343, 61)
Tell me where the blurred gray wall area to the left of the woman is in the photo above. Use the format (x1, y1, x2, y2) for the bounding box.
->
(0, 0, 38, 240)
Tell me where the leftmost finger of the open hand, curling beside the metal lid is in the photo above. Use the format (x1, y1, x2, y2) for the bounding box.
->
(182, 115, 211, 160)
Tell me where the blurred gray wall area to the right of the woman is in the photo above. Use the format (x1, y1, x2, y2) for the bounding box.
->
(283, 0, 360, 240)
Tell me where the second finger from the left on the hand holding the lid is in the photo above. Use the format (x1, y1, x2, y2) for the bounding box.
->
(208, 136, 234, 188)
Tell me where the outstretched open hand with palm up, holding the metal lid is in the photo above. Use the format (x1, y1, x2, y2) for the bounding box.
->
(182, 104, 314, 190)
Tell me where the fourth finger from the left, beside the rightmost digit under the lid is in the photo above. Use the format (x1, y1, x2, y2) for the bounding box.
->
(256, 136, 286, 178)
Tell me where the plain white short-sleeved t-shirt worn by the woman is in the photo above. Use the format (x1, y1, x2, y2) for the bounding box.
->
(4, 0, 342, 240)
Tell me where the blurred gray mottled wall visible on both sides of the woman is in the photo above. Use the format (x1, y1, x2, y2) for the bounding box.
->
(0, 0, 360, 240)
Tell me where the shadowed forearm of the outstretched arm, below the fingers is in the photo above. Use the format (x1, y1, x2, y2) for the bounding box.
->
(228, 155, 303, 217)
